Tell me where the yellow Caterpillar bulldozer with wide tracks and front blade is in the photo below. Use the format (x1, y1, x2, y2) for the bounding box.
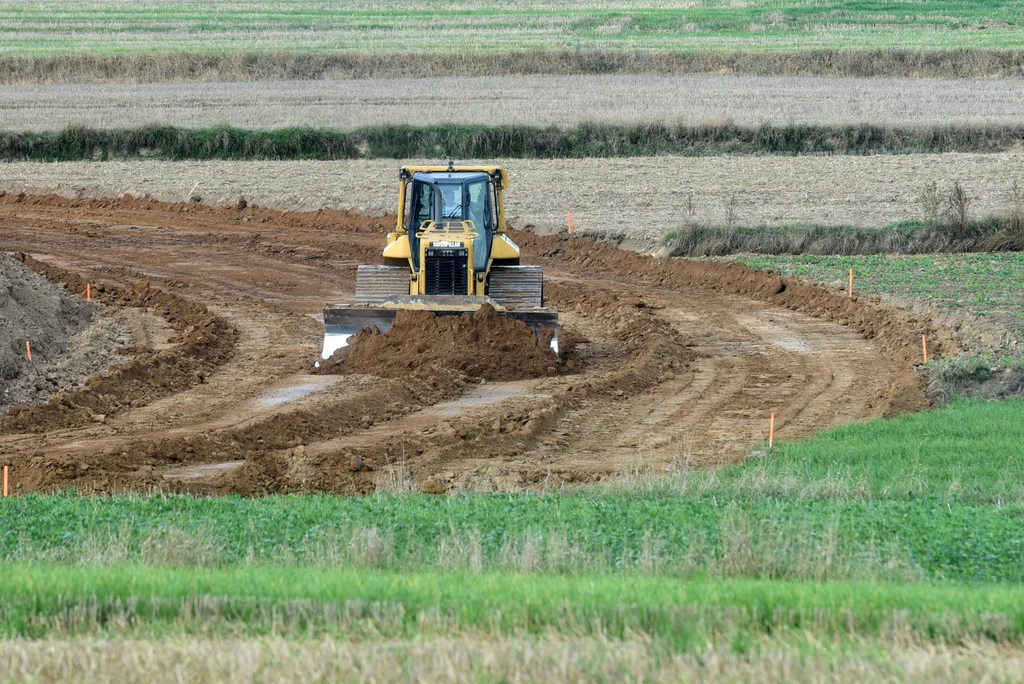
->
(321, 161, 558, 358)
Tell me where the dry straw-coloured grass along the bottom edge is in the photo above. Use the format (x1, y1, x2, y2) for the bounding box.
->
(8, 636, 1024, 684)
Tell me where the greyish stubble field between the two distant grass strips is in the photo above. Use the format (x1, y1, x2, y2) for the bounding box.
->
(6, 74, 1024, 131)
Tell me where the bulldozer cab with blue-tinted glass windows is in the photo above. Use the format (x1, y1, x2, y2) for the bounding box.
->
(404, 171, 496, 272)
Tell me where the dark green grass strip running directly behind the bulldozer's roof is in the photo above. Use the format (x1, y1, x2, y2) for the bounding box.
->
(0, 124, 1024, 162)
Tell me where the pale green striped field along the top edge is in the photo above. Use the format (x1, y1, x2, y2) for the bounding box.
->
(0, 0, 1022, 54)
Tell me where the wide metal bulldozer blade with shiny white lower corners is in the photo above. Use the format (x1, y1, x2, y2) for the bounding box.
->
(321, 296, 558, 358)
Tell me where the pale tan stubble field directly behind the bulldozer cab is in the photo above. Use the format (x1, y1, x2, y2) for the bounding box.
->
(0, 154, 1024, 245)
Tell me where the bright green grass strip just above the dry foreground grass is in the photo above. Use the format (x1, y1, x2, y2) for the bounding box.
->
(0, 565, 1024, 650)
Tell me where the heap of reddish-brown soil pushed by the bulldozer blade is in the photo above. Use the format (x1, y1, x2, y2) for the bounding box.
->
(321, 304, 563, 381)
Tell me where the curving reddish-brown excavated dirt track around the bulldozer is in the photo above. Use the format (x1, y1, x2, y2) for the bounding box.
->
(0, 195, 959, 495)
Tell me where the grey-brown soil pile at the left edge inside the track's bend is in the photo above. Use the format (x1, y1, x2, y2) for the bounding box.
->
(0, 254, 112, 416)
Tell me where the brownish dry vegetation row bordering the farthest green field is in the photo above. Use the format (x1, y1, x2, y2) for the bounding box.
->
(6, 48, 1024, 84)
